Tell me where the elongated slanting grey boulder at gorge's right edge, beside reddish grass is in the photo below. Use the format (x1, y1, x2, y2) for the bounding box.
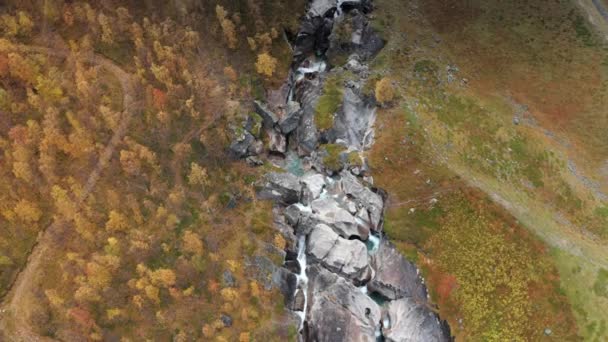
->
(340, 172, 384, 230)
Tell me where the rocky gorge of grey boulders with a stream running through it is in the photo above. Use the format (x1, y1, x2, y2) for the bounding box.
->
(231, 0, 451, 341)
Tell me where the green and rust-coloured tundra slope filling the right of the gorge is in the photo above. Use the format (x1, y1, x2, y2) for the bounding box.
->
(370, 0, 608, 341)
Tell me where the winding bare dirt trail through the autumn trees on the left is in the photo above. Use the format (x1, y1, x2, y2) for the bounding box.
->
(0, 45, 140, 342)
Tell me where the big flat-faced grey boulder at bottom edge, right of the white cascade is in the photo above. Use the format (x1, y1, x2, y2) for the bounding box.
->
(304, 265, 381, 342)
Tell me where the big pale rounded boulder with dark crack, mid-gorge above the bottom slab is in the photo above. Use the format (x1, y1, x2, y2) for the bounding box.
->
(307, 224, 371, 284)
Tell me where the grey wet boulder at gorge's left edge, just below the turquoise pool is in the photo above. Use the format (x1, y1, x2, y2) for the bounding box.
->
(258, 172, 302, 204)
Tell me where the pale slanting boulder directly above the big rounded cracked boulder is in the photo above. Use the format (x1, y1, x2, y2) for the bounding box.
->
(311, 197, 369, 241)
